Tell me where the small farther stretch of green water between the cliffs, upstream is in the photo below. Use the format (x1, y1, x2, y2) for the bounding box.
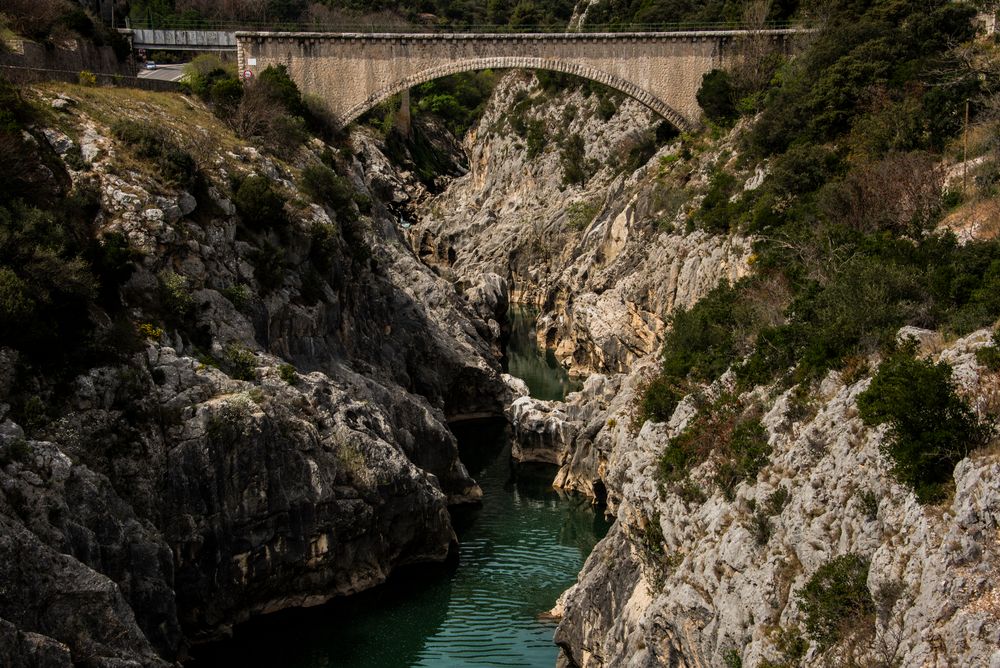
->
(507, 306, 582, 400)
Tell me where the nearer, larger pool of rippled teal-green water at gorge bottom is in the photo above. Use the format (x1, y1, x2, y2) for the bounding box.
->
(188, 421, 608, 668)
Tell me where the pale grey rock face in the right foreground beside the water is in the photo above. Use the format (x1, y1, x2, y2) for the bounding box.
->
(556, 331, 1000, 666)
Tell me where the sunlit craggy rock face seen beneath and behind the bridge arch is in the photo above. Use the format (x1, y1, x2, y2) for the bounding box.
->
(409, 73, 750, 377)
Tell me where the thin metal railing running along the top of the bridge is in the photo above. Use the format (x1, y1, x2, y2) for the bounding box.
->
(128, 17, 805, 34)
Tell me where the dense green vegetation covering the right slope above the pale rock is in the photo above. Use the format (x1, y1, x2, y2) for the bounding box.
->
(642, 0, 1000, 430)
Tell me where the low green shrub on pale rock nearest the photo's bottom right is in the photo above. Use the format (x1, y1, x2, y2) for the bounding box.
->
(796, 554, 875, 648)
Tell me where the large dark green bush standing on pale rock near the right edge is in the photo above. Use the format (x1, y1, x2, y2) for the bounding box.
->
(858, 345, 992, 503)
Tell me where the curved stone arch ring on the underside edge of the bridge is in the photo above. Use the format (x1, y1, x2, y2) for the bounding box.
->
(338, 56, 694, 131)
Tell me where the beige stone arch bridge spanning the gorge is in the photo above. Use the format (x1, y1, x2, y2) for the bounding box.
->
(236, 29, 802, 130)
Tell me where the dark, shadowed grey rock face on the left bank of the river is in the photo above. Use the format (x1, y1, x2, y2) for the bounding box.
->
(0, 85, 511, 666)
